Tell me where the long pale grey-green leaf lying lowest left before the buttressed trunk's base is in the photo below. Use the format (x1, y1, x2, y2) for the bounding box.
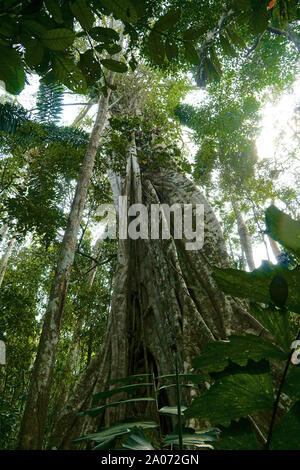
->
(73, 419, 158, 442)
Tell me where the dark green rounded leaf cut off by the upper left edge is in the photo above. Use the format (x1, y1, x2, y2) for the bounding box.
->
(0, 46, 25, 95)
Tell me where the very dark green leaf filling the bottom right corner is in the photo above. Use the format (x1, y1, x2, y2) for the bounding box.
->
(270, 401, 300, 450)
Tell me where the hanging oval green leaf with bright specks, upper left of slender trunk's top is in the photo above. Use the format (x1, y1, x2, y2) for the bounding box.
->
(53, 54, 86, 93)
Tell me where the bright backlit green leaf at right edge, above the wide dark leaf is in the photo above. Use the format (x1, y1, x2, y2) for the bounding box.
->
(265, 205, 300, 256)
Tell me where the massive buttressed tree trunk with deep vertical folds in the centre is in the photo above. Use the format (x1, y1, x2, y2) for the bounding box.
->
(51, 160, 257, 449)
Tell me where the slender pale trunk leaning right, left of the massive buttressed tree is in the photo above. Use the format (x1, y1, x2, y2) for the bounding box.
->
(18, 86, 112, 449)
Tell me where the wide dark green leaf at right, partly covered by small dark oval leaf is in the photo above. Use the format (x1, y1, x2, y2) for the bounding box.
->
(213, 262, 300, 313)
